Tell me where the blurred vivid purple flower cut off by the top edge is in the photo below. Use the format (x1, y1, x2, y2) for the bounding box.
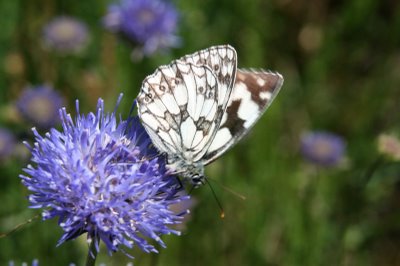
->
(104, 0, 180, 55)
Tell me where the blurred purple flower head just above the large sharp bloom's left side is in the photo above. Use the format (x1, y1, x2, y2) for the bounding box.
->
(16, 86, 63, 128)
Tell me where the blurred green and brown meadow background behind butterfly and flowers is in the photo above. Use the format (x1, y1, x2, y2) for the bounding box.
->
(0, 0, 400, 265)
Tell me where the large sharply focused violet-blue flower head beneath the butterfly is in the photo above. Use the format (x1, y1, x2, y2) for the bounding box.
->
(21, 95, 188, 255)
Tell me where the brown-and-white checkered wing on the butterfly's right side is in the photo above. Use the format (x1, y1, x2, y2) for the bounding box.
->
(203, 69, 283, 164)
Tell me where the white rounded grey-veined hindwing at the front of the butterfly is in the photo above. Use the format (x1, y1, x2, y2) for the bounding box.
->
(137, 61, 223, 161)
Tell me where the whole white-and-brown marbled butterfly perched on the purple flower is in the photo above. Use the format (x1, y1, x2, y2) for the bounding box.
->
(136, 45, 283, 187)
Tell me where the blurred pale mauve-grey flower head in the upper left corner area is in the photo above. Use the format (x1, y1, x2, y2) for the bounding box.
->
(43, 16, 89, 53)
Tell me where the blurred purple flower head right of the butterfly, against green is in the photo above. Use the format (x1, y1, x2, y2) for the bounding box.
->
(301, 132, 346, 166)
